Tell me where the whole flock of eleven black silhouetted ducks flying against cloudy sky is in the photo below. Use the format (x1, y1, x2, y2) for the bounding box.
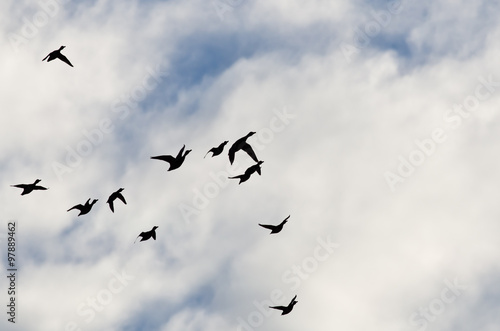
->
(11, 46, 298, 315)
